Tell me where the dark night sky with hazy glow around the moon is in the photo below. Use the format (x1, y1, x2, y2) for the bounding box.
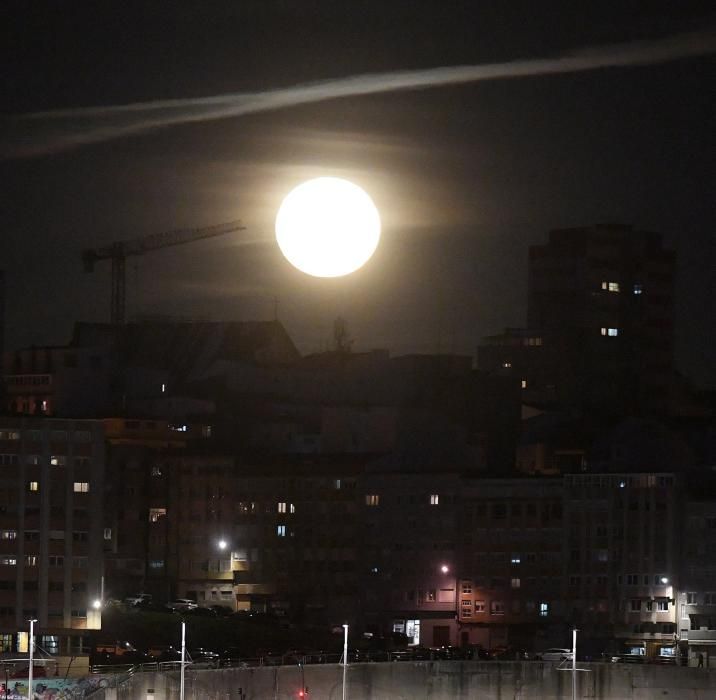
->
(0, 0, 716, 386)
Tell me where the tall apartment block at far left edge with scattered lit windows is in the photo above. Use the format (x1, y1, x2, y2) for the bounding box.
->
(0, 417, 108, 656)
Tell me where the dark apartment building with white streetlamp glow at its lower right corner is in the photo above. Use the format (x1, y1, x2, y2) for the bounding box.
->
(563, 473, 683, 662)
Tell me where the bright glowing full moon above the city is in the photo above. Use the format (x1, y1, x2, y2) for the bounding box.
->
(276, 177, 380, 277)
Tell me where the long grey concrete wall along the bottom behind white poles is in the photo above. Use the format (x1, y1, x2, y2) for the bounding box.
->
(93, 661, 716, 700)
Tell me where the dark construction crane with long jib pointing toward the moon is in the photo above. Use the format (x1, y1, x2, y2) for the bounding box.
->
(82, 221, 246, 323)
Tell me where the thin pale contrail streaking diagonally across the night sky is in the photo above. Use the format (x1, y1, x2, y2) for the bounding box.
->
(0, 29, 716, 159)
